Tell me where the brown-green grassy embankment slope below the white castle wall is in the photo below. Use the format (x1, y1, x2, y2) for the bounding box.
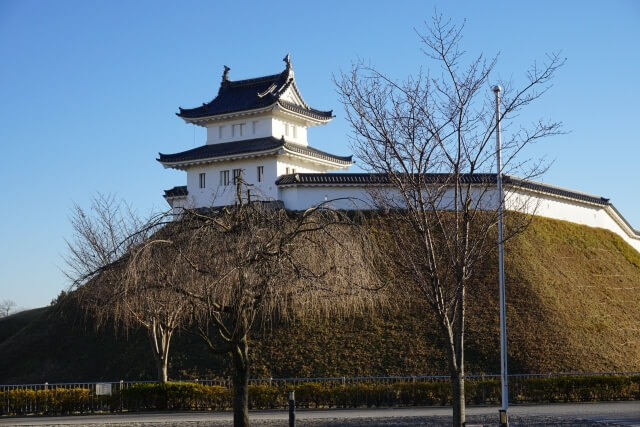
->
(0, 218, 640, 384)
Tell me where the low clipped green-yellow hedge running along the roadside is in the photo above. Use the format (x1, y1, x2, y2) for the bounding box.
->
(0, 375, 640, 415)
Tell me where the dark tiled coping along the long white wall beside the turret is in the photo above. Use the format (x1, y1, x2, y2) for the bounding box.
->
(276, 173, 609, 205)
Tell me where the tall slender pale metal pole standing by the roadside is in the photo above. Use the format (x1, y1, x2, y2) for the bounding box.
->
(493, 85, 509, 427)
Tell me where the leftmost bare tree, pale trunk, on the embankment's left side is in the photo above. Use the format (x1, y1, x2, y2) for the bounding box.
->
(65, 195, 189, 382)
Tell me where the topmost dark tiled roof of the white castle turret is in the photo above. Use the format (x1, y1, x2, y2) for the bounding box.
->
(176, 67, 333, 120)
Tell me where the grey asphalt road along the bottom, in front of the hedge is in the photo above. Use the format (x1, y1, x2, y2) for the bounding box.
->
(0, 402, 640, 427)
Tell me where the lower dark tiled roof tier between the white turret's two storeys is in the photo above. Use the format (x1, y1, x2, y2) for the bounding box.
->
(157, 137, 352, 164)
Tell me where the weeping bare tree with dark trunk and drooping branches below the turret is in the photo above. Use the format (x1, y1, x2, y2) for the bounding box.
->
(169, 186, 382, 426)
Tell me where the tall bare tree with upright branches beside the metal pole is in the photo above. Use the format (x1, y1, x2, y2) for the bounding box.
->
(336, 16, 563, 426)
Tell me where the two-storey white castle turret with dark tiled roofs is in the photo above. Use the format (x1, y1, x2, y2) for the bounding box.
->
(158, 55, 353, 208)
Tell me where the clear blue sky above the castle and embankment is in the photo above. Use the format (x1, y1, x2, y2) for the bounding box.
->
(0, 0, 640, 308)
